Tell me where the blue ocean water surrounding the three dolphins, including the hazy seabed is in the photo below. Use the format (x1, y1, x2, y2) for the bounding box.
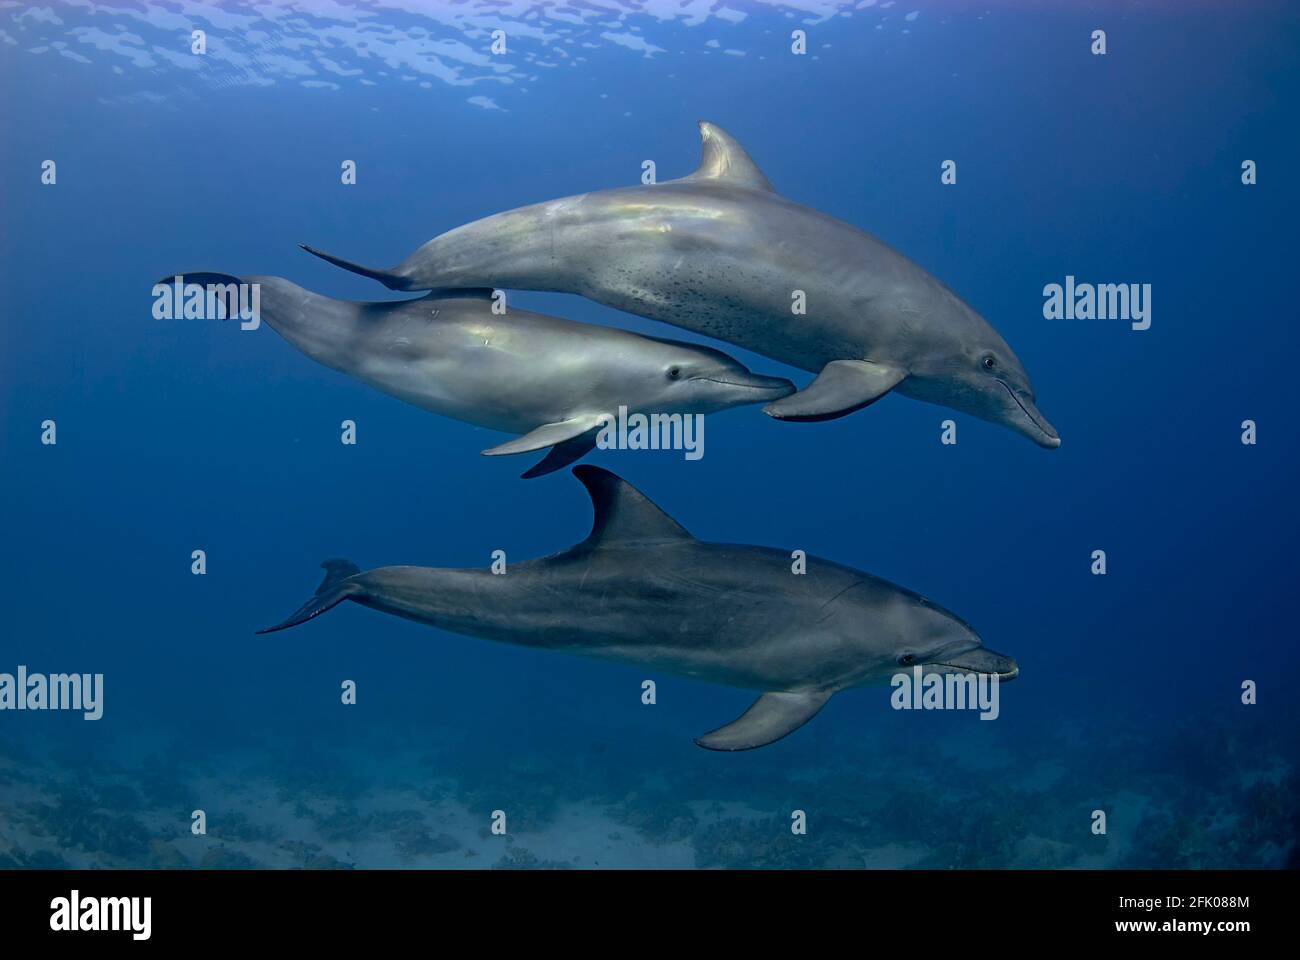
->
(0, 0, 1300, 868)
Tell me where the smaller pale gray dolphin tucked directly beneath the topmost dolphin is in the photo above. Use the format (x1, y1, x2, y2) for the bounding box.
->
(161, 273, 794, 479)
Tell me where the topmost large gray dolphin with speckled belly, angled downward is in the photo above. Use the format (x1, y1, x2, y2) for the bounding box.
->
(306, 122, 1061, 447)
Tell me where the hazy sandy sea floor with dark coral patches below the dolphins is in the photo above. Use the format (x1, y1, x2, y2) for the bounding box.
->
(0, 707, 1300, 869)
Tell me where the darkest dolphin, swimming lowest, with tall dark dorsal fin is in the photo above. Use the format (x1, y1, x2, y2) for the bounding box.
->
(259, 464, 1019, 751)
